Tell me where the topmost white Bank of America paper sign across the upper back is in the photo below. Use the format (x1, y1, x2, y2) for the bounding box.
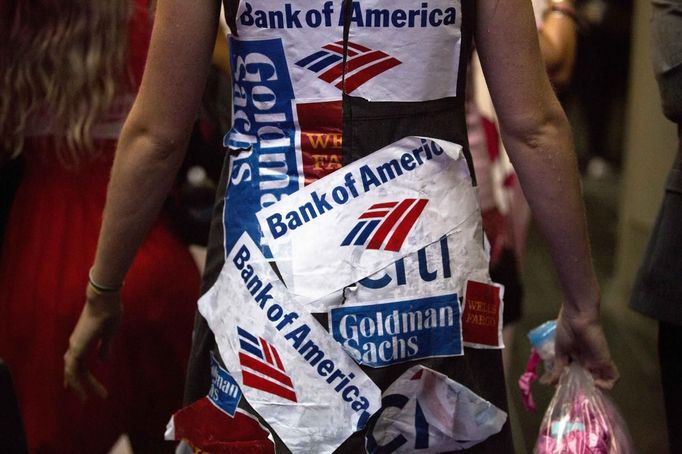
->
(232, 0, 463, 104)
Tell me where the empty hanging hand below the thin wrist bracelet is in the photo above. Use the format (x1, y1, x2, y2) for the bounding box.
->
(64, 284, 122, 400)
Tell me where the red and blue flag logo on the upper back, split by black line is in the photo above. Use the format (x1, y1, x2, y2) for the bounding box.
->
(296, 41, 402, 93)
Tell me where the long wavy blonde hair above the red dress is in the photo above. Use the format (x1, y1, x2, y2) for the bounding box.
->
(0, 0, 132, 164)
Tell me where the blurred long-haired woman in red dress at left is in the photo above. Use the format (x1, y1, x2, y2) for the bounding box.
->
(0, 0, 199, 453)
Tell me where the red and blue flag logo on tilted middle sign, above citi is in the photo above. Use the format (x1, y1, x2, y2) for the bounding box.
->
(341, 199, 429, 252)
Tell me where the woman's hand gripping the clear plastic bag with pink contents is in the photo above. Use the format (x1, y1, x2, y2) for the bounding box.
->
(543, 308, 619, 389)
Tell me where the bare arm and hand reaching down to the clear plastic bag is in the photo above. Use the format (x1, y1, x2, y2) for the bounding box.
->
(476, 0, 617, 386)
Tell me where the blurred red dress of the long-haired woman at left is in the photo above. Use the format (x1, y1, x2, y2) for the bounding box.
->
(0, 1, 200, 453)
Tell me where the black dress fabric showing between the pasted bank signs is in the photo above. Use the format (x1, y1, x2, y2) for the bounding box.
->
(185, 0, 512, 454)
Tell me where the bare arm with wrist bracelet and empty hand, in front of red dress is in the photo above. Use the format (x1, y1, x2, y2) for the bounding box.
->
(64, 0, 219, 398)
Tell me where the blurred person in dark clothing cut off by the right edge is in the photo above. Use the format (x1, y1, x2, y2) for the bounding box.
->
(630, 0, 682, 453)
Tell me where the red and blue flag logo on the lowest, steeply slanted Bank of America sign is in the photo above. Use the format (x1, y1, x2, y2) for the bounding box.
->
(237, 327, 296, 402)
